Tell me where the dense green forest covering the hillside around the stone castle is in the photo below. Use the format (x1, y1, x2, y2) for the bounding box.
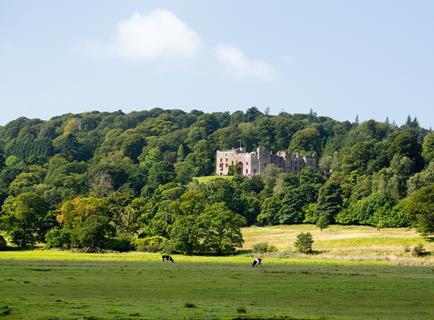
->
(0, 107, 434, 255)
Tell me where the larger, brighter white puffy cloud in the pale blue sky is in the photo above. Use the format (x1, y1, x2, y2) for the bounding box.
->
(87, 9, 201, 61)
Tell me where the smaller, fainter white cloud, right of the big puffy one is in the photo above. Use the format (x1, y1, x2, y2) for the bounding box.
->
(215, 45, 278, 81)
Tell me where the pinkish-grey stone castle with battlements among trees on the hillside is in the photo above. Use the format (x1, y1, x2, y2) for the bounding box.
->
(215, 147, 317, 176)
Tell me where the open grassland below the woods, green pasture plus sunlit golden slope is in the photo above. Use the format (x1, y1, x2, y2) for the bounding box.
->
(0, 226, 434, 319)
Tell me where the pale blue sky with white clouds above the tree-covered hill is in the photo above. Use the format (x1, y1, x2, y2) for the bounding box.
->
(0, 0, 434, 128)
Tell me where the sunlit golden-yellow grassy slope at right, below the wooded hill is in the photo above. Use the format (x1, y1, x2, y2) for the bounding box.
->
(242, 225, 434, 265)
